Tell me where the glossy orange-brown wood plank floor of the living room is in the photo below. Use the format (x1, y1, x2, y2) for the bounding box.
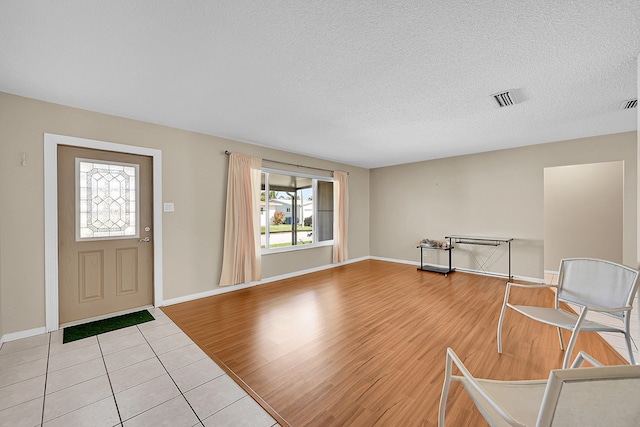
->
(163, 260, 625, 426)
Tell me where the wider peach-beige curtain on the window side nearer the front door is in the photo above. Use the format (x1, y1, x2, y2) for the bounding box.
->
(220, 153, 262, 286)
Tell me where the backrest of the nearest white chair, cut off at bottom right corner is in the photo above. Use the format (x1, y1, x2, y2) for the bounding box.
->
(537, 365, 640, 426)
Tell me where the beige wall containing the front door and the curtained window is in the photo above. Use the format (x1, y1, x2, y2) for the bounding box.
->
(0, 93, 369, 335)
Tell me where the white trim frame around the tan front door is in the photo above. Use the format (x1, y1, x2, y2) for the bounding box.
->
(44, 133, 162, 332)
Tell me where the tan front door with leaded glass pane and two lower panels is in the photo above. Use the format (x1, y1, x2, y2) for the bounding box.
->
(58, 145, 153, 324)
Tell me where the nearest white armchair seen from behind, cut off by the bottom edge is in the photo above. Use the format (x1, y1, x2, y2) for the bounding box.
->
(438, 348, 640, 427)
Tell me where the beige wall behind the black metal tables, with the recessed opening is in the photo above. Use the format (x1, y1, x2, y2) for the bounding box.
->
(370, 132, 637, 279)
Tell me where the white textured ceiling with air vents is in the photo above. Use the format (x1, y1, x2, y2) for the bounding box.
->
(0, 0, 640, 167)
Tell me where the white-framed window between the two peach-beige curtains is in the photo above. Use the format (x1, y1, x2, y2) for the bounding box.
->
(260, 169, 333, 251)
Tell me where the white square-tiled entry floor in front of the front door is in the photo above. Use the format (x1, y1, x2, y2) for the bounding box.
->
(0, 309, 278, 427)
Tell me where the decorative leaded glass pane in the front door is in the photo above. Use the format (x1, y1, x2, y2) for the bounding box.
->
(75, 158, 139, 241)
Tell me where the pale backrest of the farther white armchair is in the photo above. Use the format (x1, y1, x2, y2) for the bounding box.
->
(558, 258, 638, 317)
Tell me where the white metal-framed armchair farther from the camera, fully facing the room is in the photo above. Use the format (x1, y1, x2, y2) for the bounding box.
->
(498, 258, 639, 369)
